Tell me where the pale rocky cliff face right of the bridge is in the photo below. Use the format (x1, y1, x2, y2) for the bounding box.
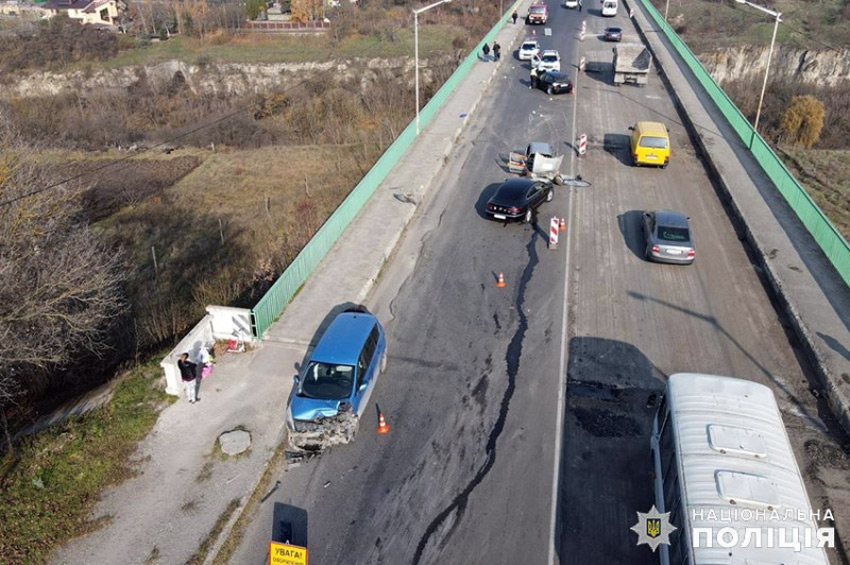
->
(699, 46, 850, 86)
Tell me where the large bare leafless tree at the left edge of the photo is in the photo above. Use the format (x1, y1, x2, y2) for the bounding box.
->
(0, 124, 125, 440)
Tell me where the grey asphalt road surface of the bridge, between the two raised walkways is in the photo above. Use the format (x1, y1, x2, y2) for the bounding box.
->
(232, 6, 850, 565)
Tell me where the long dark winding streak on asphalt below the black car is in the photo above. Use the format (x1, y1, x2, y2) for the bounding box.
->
(413, 230, 538, 565)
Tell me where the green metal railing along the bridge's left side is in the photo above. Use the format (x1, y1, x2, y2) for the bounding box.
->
(251, 8, 519, 338)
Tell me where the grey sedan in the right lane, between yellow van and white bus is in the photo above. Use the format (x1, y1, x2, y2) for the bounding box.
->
(641, 210, 696, 265)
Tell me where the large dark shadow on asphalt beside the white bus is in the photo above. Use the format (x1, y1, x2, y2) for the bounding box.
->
(555, 337, 667, 565)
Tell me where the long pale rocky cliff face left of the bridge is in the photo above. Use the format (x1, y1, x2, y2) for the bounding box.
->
(0, 57, 446, 98)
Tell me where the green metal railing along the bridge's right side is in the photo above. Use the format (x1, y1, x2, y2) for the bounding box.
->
(638, 0, 850, 285)
